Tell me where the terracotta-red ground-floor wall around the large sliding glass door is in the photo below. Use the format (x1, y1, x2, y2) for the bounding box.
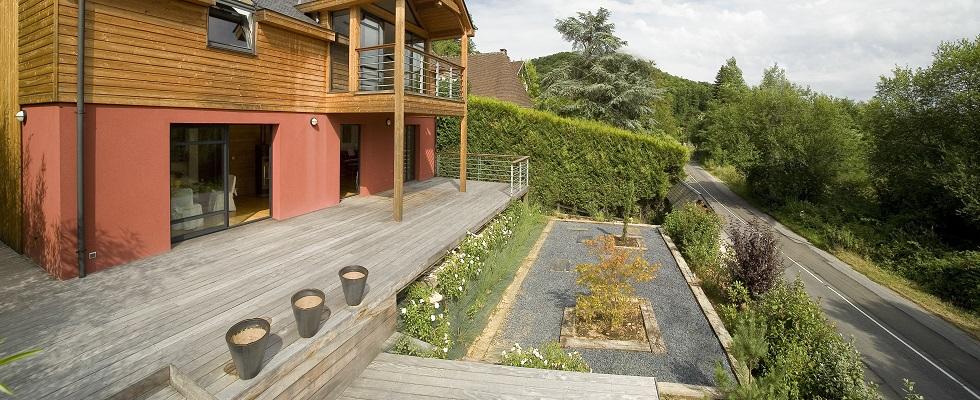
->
(23, 104, 340, 278)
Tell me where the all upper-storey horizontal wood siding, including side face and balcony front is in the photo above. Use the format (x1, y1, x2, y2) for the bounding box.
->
(18, 0, 463, 115)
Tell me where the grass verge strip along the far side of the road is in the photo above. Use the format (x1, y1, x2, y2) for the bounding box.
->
(707, 166, 980, 340)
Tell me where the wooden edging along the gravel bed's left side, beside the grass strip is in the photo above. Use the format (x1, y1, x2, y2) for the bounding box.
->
(463, 218, 556, 361)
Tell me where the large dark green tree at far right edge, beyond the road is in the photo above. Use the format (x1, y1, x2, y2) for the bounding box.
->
(868, 36, 980, 238)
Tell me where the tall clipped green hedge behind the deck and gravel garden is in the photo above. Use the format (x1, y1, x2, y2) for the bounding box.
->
(438, 96, 689, 216)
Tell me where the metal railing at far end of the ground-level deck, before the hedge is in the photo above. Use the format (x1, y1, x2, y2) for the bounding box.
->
(436, 151, 531, 196)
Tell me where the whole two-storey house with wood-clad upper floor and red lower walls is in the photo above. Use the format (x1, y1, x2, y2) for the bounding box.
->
(0, 0, 473, 278)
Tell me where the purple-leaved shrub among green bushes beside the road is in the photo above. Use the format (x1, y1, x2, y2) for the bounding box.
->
(725, 220, 783, 299)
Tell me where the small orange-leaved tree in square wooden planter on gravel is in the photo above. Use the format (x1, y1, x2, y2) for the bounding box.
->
(575, 235, 660, 337)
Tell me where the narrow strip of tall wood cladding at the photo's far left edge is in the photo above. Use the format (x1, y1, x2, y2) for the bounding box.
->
(0, 1, 25, 251)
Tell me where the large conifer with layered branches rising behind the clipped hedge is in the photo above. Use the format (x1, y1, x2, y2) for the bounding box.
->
(540, 8, 659, 131)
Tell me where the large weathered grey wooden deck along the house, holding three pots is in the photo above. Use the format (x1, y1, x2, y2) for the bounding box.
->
(0, 178, 512, 399)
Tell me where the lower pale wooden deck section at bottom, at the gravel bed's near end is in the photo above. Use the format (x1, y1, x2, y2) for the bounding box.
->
(341, 354, 659, 400)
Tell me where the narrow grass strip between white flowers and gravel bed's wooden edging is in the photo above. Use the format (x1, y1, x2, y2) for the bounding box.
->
(448, 207, 548, 359)
